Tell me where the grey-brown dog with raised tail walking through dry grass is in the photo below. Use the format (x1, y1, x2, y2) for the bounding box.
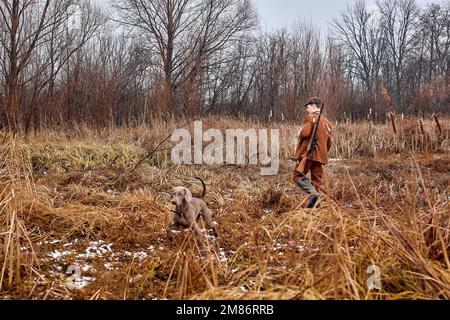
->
(167, 178, 218, 246)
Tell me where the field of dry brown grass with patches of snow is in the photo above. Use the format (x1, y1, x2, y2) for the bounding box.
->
(0, 117, 450, 299)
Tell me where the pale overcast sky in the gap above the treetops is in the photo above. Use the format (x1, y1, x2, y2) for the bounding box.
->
(252, 0, 446, 35)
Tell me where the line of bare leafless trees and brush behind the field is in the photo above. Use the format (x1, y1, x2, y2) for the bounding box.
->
(0, 0, 450, 133)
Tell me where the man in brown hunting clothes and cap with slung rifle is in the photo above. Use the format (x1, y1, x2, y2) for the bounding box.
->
(293, 97, 332, 208)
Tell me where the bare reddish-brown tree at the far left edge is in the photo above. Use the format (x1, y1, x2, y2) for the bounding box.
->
(0, 0, 103, 133)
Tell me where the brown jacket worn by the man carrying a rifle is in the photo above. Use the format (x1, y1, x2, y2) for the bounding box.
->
(295, 113, 332, 164)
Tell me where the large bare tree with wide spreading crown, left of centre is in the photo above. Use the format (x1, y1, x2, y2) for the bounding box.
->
(115, 0, 255, 113)
